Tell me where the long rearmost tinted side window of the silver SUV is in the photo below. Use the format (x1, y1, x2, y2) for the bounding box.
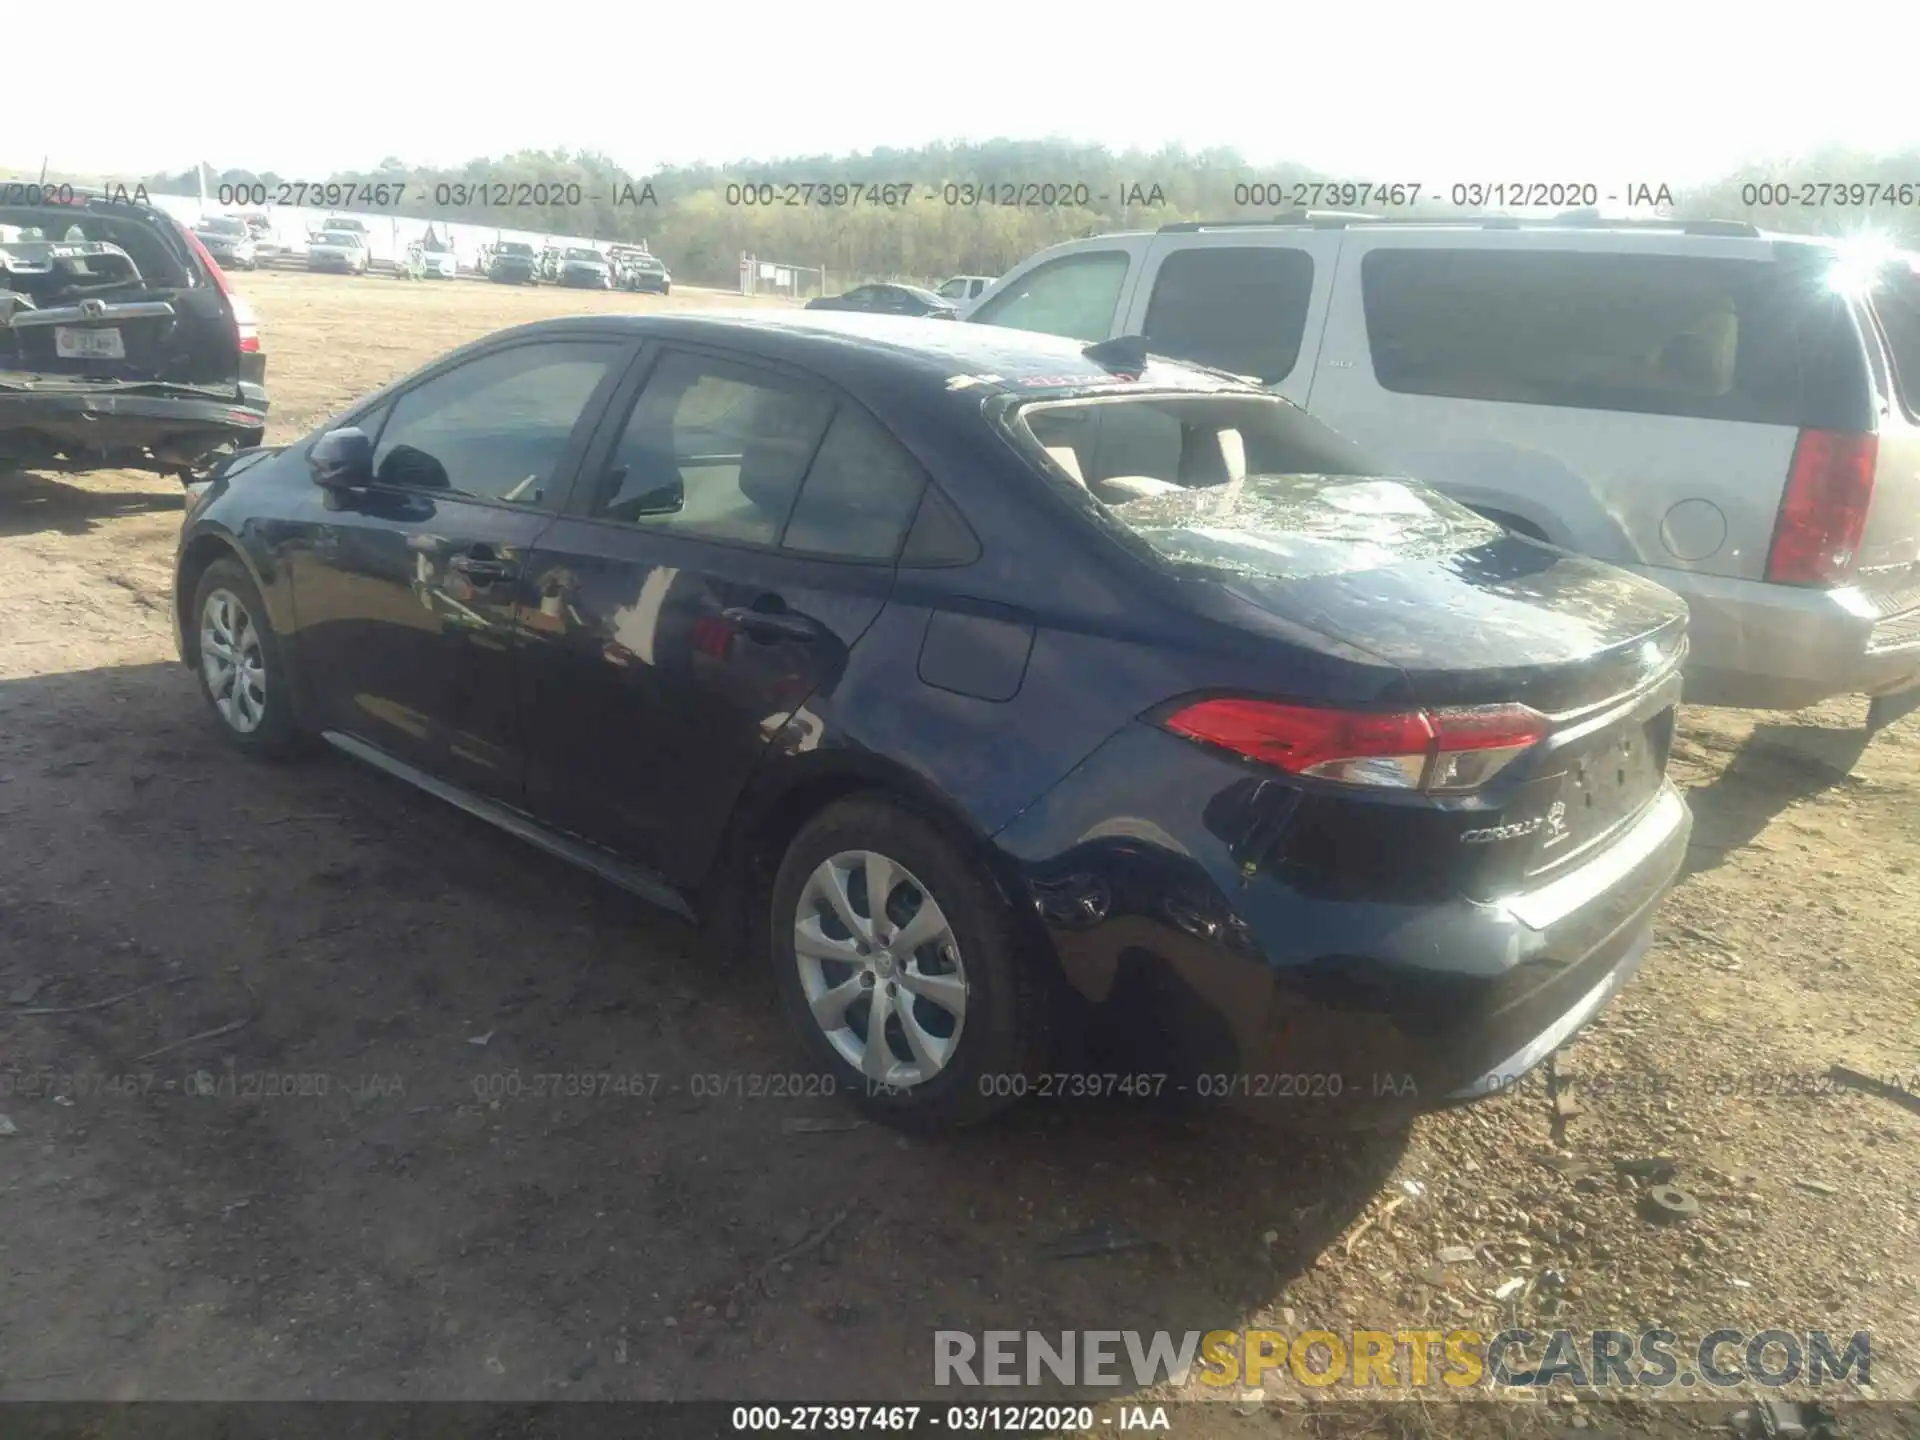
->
(1361, 248, 1870, 428)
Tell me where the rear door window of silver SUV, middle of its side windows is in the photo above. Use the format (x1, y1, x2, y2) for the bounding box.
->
(1144, 246, 1313, 384)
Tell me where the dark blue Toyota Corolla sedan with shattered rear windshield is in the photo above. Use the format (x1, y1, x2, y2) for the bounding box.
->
(175, 313, 1690, 1127)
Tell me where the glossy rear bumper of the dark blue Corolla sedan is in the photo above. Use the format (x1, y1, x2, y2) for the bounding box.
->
(996, 726, 1692, 1129)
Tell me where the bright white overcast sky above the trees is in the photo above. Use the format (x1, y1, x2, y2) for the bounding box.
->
(11, 0, 1920, 186)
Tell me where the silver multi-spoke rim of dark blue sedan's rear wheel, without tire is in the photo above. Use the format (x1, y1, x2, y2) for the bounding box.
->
(793, 851, 968, 1091)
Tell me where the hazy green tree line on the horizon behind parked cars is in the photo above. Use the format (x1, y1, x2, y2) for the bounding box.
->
(140, 140, 1920, 288)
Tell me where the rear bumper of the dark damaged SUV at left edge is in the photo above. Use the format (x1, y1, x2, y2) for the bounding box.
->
(0, 382, 267, 468)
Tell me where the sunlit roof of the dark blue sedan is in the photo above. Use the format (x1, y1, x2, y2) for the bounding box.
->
(480, 309, 1267, 396)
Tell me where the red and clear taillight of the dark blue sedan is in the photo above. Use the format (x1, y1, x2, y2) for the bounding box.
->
(1162, 699, 1549, 793)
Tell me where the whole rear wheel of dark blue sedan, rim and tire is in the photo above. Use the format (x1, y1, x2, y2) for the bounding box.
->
(772, 799, 1050, 1129)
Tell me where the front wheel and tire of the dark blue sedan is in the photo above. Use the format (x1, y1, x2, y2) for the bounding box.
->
(192, 559, 300, 756)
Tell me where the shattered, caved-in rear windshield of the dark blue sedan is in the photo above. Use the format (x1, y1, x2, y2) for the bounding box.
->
(1012, 394, 1501, 580)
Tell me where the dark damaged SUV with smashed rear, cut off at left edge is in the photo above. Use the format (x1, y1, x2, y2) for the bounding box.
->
(0, 180, 267, 480)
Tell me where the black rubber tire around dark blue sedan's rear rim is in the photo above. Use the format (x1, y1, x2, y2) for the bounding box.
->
(768, 795, 1052, 1131)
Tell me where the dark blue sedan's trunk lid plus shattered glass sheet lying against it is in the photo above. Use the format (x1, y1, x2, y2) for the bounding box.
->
(1116, 476, 1686, 899)
